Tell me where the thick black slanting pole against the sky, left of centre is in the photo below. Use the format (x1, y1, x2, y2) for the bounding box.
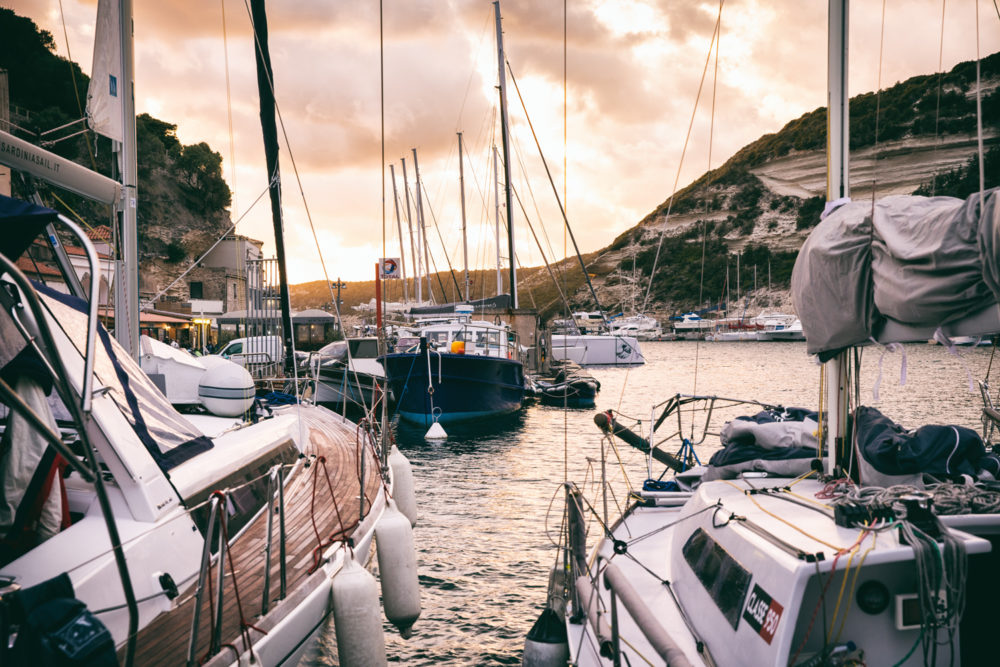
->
(250, 0, 295, 374)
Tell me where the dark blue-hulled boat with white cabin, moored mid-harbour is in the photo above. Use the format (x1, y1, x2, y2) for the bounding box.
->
(380, 319, 524, 426)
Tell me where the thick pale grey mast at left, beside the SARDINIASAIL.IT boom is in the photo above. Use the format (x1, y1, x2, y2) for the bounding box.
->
(115, 0, 139, 359)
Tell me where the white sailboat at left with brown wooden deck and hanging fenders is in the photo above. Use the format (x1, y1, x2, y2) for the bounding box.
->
(0, 1, 419, 665)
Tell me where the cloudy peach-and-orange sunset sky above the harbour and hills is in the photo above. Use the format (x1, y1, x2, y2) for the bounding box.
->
(9, 0, 1000, 282)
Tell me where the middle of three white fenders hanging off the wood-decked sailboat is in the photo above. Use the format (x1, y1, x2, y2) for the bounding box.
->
(376, 500, 420, 641)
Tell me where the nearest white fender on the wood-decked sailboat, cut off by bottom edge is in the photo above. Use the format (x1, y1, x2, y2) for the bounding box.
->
(332, 557, 386, 667)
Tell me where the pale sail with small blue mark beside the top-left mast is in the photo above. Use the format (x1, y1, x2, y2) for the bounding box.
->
(87, 0, 123, 141)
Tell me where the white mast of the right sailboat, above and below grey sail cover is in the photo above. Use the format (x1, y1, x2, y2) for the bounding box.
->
(820, 0, 850, 474)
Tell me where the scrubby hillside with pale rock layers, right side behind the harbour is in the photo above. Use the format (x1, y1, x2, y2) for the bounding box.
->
(575, 53, 1000, 314)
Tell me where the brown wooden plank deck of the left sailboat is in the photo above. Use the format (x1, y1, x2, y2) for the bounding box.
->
(127, 414, 381, 666)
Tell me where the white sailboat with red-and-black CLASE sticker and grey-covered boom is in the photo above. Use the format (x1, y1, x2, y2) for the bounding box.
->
(525, 0, 1000, 667)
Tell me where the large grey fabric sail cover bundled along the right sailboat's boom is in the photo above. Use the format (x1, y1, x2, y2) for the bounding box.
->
(792, 188, 1000, 359)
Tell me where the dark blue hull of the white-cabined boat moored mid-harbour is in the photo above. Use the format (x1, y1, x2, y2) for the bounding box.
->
(379, 352, 524, 426)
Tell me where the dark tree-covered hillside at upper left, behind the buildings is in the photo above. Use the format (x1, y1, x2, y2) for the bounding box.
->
(0, 7, 231, 298)
